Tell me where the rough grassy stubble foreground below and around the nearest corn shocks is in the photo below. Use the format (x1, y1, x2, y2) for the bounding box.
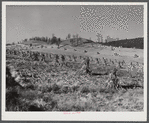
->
(6, 57, 144, 112)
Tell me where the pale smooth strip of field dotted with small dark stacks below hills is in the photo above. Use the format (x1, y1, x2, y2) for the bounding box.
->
(33, 44, 144, 63)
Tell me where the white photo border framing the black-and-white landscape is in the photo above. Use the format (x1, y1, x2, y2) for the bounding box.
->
(1, 2, 148, 121)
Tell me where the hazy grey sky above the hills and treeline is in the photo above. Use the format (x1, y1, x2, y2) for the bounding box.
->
(6, 5, 144, 43)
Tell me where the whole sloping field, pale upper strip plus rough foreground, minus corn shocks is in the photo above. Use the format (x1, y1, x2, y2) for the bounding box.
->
(6, 40, 144, 112)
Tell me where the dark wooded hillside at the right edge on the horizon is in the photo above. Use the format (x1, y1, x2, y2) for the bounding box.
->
(102, 38, 144, 49)
